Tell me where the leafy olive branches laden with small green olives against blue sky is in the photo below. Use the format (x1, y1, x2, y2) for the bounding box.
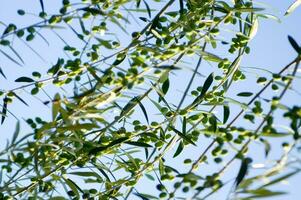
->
(0, 0, 301, 200)
